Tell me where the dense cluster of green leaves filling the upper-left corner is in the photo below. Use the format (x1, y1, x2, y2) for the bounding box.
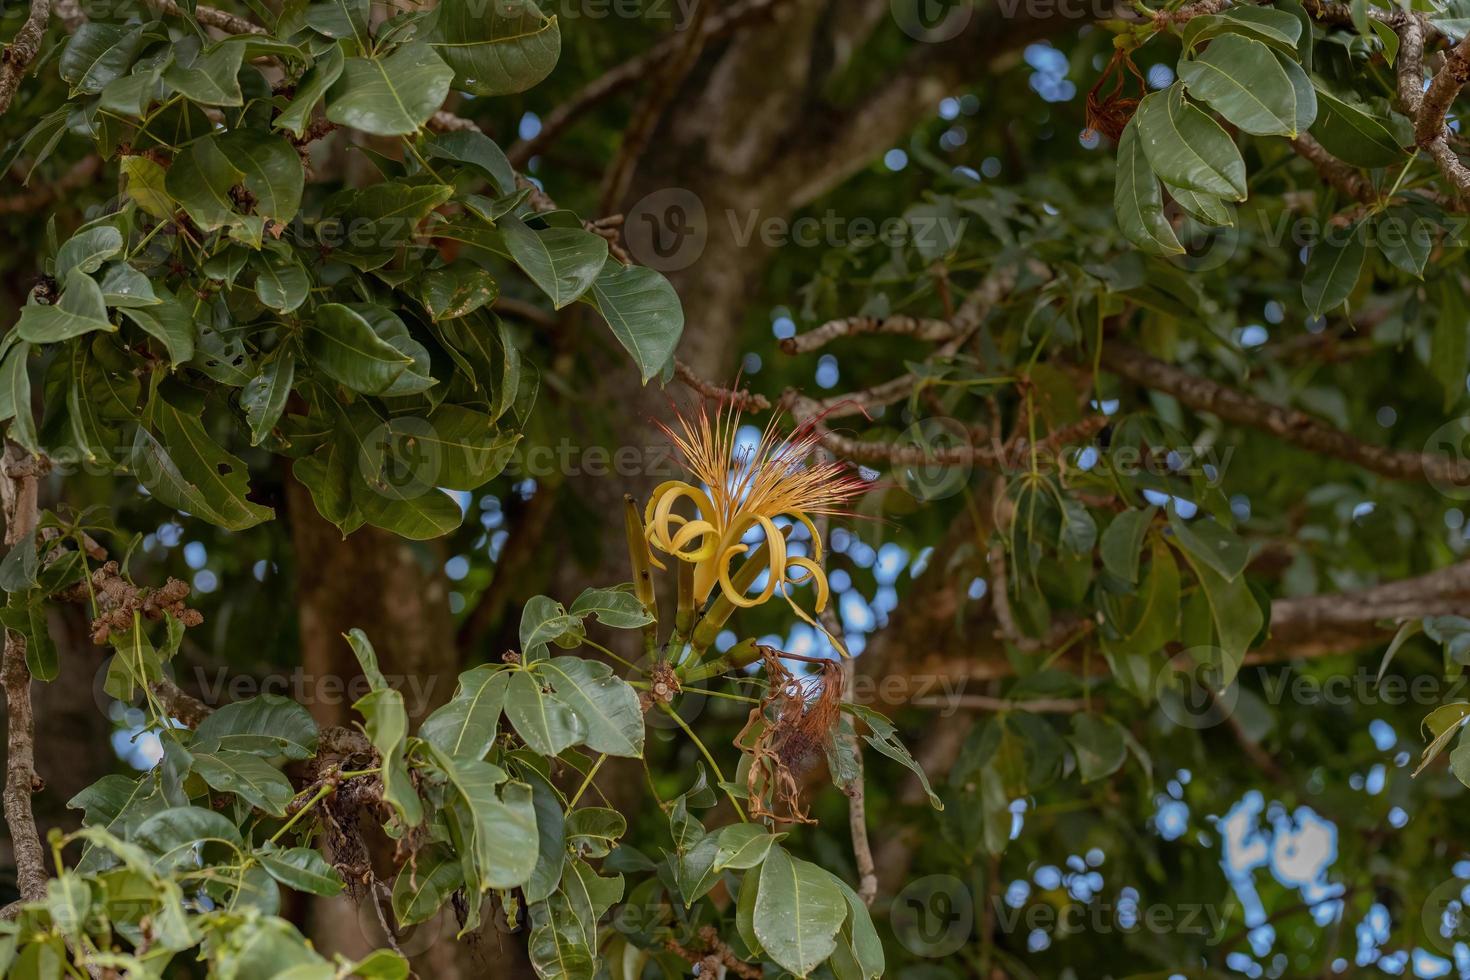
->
(0, 3, 684, 538)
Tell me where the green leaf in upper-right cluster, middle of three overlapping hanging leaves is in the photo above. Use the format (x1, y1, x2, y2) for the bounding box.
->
(1130, 82, 1245, 201)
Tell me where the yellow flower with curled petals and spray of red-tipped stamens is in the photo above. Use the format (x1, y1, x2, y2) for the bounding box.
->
(644, 404, 867, 642)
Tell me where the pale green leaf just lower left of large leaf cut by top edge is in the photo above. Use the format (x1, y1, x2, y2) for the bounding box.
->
(326, 43, 454, 137)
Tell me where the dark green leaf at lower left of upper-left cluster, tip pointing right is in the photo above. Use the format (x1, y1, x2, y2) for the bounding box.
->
(129, 400, 275, 530)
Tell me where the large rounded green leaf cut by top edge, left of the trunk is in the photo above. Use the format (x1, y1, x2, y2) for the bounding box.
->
(429, 0, 562, 96)
